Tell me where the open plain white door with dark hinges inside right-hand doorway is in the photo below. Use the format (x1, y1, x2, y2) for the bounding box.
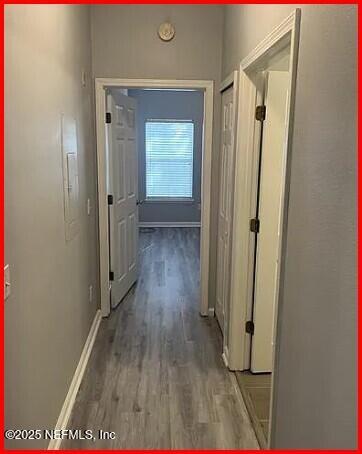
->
(251, 71, 289, 372)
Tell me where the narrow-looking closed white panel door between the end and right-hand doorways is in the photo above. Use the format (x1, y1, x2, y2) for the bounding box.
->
(215, 86, 235, 336)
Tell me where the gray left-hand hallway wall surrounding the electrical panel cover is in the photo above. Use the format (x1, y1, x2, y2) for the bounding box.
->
(5, 5, 98, 448)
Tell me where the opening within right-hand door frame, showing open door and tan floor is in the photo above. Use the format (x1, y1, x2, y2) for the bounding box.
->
(236, 62, 290, 446)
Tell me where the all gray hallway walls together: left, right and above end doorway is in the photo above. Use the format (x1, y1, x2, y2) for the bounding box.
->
(5, 5, 356, 448)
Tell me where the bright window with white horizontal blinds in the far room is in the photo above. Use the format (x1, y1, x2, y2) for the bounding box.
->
(146, 120, 194, 199)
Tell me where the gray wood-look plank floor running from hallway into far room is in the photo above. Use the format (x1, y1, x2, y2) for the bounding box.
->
(61, 228, 258, 449)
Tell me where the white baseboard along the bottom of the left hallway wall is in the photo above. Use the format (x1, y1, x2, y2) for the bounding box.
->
(48, 310, 101, 450)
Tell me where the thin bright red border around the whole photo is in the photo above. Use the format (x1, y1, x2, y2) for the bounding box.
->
(0, 0, 362, 454)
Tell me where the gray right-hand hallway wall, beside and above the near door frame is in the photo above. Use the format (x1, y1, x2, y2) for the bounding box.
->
(223, 5, 357, 448)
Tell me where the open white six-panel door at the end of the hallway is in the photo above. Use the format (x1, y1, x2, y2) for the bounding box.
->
(107, 90, 138, 307)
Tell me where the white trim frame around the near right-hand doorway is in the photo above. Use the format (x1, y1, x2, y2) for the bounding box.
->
(228, 9, 300, 436)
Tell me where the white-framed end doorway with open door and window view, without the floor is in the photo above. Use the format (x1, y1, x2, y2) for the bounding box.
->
(96, 79, 213, 316)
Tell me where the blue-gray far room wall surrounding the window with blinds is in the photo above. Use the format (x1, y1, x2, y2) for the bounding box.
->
(128, 90, 204, 222)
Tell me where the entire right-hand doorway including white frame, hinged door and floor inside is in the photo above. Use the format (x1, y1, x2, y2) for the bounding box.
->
(228, 10, 300, 448)
